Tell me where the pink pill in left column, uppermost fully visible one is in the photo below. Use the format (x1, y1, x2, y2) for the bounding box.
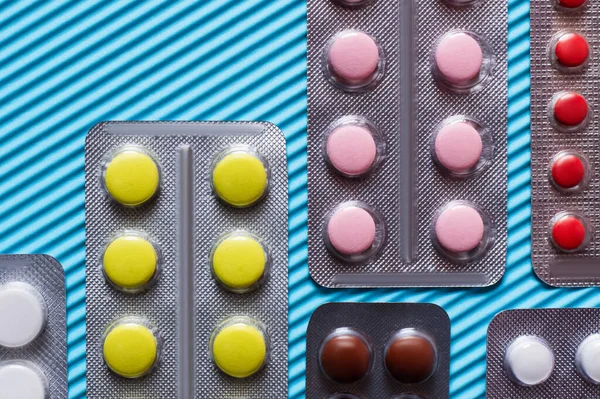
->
(328, 31, 379, 85)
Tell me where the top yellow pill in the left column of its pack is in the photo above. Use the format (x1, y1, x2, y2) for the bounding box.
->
(104, 149, 160, 206)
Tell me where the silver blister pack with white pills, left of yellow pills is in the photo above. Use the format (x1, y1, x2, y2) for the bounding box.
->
(0, 255, 67, 399)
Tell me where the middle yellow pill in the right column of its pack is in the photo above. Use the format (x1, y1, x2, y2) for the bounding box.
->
(211, 233, 267, 292)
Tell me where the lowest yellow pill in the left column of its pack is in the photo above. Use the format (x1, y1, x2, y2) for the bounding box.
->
(103, 322, 158, 378)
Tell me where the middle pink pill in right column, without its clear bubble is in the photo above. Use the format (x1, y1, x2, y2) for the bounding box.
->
(435, 122, 483, 173)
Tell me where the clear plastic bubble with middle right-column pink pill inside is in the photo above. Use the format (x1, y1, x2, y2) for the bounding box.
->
(431, 115, 493, 177)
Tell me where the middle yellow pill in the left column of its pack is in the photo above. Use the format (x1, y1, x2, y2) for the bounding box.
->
(102, 235, 158, 291)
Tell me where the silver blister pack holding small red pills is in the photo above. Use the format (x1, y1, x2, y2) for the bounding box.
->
(531, 0, 600, 286)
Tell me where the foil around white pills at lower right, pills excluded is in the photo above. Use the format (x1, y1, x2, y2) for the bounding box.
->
(486, 309, 600, 399)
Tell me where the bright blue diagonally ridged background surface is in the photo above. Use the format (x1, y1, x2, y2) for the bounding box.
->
(0, 0, 600, 398)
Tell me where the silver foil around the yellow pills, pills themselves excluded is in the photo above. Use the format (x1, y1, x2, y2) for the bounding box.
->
(86, 122, 287, 398)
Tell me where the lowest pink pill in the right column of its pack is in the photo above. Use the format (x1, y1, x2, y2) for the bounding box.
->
(435, 205, 484, 252)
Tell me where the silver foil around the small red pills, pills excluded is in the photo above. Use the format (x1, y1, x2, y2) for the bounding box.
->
(531, 0, 600, 287)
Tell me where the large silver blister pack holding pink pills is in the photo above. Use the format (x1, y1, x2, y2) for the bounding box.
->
(308, 0, 507, 287)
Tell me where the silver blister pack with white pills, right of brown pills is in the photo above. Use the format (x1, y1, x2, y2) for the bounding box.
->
(486, 309, 600, 399)
